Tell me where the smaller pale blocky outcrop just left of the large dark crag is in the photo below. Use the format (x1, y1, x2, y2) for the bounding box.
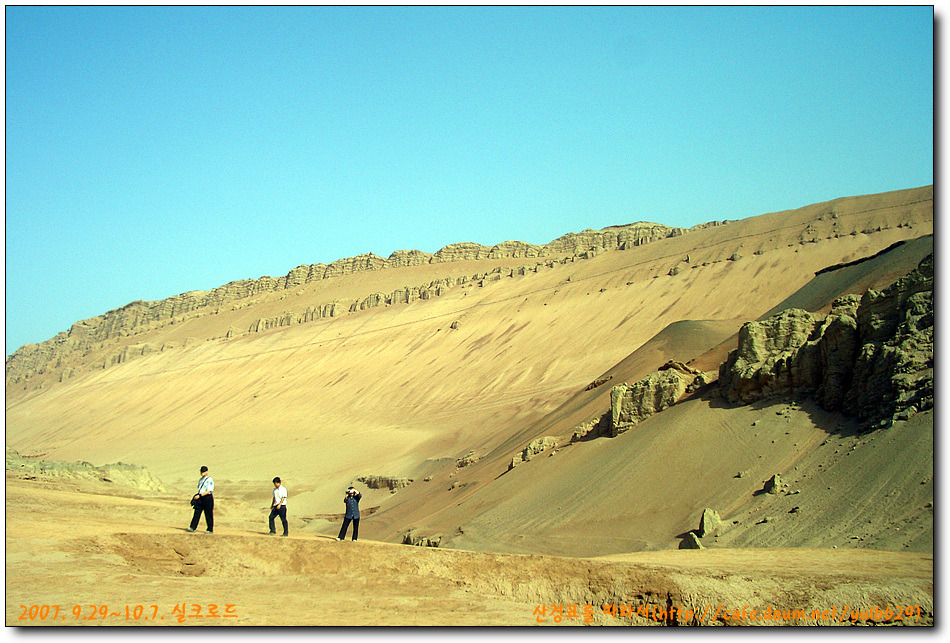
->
(609, 361, 702, 437)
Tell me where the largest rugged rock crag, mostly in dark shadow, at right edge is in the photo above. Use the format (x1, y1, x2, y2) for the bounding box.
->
(719, 255, 934, 426)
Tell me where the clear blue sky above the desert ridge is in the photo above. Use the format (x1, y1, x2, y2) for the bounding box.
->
(5, 7, 934, 354)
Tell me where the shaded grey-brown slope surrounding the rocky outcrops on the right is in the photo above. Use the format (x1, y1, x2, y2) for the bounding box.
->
(364, 238, 933, 556)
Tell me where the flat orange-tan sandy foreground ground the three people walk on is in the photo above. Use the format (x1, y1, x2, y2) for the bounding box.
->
(6, 466, 934, 627)
